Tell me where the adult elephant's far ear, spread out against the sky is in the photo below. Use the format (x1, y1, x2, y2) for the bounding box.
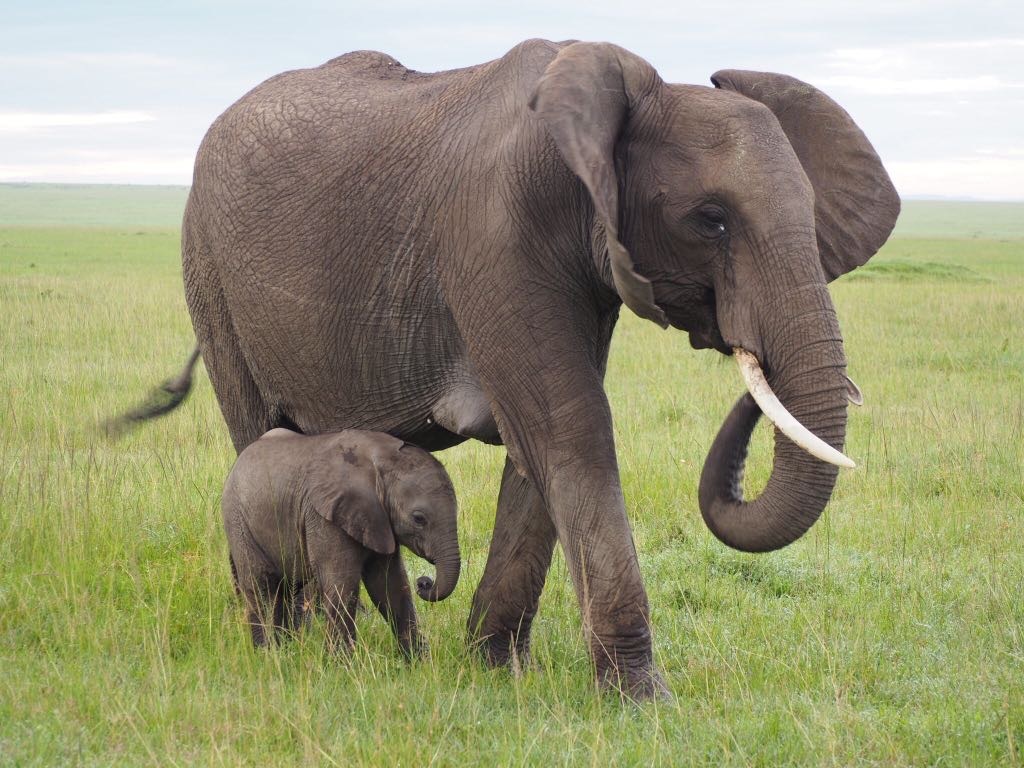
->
(711, 70, 900, 281)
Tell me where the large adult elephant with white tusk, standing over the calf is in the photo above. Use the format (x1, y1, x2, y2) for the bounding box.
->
(125, 41, 899, 697)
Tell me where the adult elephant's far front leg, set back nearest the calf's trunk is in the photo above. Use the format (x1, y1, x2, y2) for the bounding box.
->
(468, 459, 556, 666)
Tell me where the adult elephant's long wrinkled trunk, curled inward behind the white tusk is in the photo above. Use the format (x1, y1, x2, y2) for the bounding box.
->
(699, 285, 853, 552)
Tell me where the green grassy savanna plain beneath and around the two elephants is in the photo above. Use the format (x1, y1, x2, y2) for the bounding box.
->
(0, 186, 1024, 766)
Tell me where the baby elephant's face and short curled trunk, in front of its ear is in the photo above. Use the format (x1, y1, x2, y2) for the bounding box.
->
(377, 444, 462, 602)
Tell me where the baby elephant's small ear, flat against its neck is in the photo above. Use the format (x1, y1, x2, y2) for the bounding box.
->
(306, 447, 395, 555)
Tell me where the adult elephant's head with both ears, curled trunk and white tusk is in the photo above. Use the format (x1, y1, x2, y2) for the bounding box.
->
(529, 43, 900, 551)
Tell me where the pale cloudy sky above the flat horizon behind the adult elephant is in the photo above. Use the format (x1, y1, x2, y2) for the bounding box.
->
(6, 0, 1024, 200)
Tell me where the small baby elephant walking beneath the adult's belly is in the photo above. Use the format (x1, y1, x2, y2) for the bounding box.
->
(221, 429, 460, 656)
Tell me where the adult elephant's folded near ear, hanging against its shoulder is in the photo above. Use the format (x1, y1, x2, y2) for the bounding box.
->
(529, 43, 669, 328)
